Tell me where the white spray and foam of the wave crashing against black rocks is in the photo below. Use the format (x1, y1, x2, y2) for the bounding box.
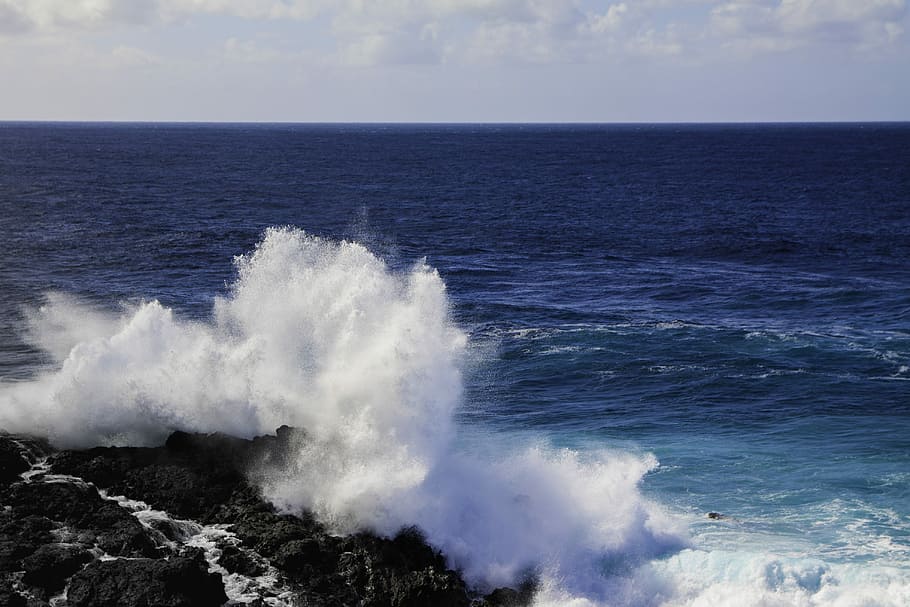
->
(0, 229, 910, 606)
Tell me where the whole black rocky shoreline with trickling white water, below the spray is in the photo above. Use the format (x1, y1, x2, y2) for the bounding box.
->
(0, 426, 533, 607)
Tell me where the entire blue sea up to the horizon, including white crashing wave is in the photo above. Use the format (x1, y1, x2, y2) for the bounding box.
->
(0, 123, 910, 607)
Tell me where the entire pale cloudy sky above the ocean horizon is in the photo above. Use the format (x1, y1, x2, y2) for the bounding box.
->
(0, 0, 910, 122)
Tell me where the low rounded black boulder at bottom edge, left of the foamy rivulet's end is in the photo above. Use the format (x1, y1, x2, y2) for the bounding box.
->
(67, 553, 228, 607)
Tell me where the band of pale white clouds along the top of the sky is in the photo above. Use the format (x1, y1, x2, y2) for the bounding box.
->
(0, 0, 907, 66)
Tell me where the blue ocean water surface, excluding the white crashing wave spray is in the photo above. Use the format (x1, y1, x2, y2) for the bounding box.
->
(0, 123, 910, 605)
